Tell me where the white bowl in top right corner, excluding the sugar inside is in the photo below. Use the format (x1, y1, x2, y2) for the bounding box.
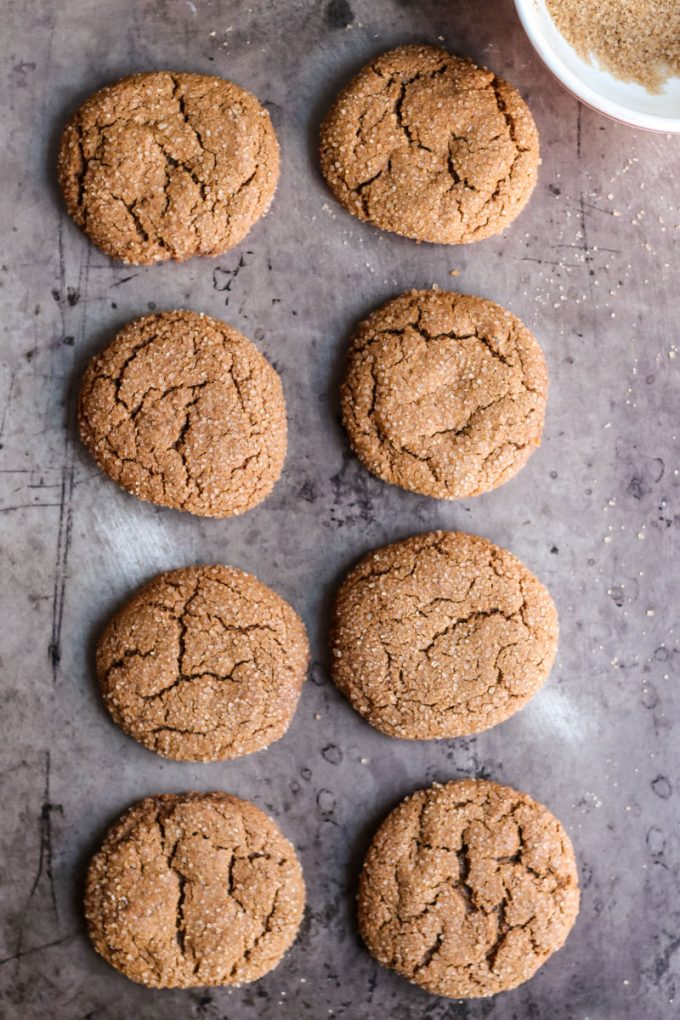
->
(515, 0, 680, 134)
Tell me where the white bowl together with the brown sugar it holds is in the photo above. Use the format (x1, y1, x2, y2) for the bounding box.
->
(515, 0, 680, 134)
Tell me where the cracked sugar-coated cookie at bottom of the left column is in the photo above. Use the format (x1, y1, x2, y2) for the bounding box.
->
(85, 793, 305, 988)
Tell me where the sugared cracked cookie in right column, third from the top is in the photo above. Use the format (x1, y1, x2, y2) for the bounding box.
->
(331, 531, 558, 741)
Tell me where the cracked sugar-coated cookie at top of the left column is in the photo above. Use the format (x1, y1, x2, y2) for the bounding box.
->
(58, 71, 279, 265)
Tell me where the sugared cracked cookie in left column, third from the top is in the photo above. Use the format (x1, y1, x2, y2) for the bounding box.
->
(97, 566, 309, 761)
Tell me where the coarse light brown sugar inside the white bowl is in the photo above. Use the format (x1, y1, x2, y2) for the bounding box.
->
(545, 0, 680, 92)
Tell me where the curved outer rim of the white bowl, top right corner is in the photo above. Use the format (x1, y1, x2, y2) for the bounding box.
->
(515, 0, 680, 135)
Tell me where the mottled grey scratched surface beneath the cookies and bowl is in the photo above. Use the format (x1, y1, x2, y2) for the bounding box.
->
(0, 0, 680, 1020)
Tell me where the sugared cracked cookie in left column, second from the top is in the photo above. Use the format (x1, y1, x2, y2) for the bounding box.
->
(79, 311, 287, 517)
